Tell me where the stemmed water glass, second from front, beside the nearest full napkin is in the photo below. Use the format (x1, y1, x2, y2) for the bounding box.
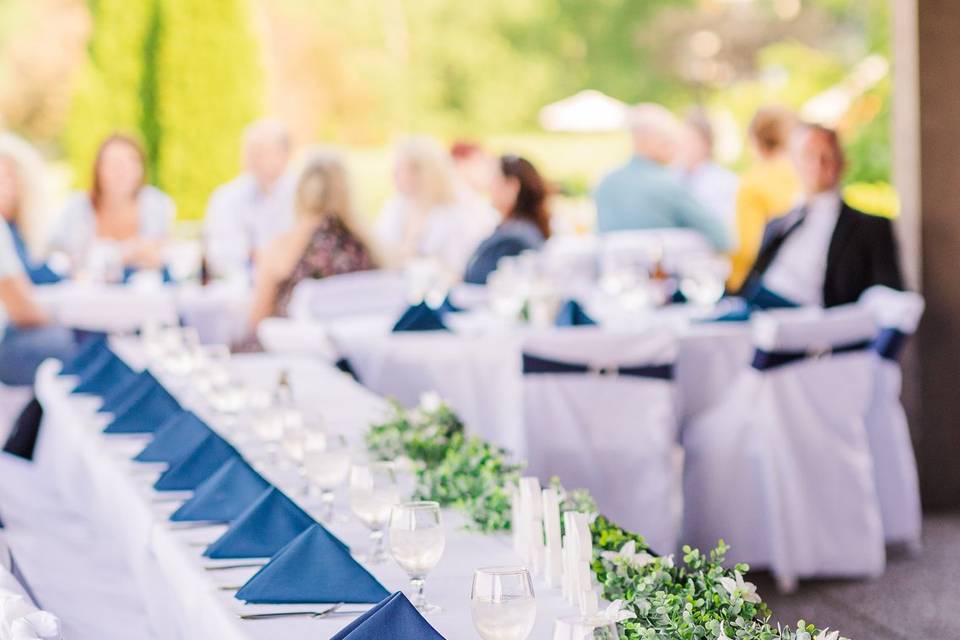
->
(390, 501, 446, 613)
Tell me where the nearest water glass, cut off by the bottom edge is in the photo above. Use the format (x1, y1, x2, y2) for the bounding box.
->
(470, 567, 537, 640)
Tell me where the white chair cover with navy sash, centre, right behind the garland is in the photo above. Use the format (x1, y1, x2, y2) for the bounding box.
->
(523, 328, 680, 554)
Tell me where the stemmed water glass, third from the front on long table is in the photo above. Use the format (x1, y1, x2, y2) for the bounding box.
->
(350, 462, 400, 564)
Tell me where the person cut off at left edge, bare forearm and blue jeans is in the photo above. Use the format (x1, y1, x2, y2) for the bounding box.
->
(0, 224, 74, 386)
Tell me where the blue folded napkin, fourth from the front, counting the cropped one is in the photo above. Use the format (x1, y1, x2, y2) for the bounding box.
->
(170, 456, 270, 522)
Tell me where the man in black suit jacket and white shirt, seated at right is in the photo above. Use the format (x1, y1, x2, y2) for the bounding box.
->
(741, 125, 903, 307)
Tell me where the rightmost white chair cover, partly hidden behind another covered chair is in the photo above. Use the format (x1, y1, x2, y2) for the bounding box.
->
(860, 286, 924, 545)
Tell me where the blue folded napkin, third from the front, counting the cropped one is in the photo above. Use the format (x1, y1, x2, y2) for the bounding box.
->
(203, 487, 316, 556)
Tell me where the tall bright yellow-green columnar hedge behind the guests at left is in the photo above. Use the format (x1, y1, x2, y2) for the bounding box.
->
(64, 0, 263, 218)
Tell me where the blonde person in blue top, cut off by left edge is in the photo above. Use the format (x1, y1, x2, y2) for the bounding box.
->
(0, 133, 60, 284)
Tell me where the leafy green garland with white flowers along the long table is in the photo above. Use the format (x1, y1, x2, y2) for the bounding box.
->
(366, 394, 844, 640)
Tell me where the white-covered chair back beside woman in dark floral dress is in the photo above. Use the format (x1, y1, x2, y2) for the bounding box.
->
(288, 271, 407, 320)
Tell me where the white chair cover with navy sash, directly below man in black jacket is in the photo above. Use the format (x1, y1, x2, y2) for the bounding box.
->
(683, 306, 885, 589)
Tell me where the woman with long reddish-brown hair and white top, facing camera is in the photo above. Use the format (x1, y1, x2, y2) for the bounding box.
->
(51, 134, 176, 269)
